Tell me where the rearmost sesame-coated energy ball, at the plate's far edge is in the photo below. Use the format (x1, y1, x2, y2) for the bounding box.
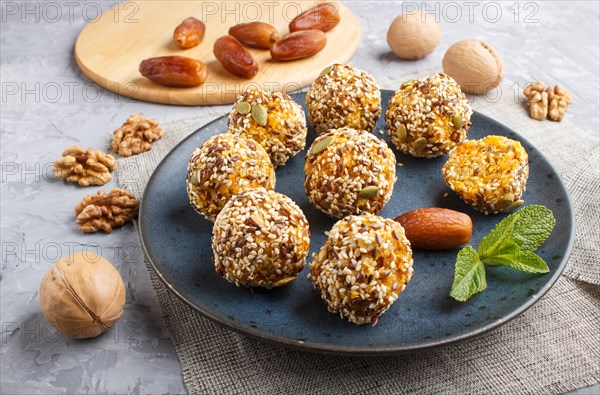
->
(306, 64, 381, 134)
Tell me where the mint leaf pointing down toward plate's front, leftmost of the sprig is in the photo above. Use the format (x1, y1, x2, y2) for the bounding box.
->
(450, 245, 487, 302)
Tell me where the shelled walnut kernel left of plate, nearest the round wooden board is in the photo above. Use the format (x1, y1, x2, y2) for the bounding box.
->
(112, 114, 164, 156)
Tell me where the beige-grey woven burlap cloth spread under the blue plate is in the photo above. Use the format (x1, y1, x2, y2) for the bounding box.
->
(117, 70, 600, 394)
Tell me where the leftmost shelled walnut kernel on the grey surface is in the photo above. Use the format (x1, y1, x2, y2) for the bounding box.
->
(53, 146, 117, 187)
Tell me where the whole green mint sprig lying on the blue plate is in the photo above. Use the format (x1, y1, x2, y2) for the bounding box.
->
(450, 206, 556, 302)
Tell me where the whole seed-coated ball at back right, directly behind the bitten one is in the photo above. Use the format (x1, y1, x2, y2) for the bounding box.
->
(385, 73, 473, 158)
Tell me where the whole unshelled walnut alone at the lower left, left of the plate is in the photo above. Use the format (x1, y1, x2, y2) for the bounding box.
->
(40, 252, 125, 339)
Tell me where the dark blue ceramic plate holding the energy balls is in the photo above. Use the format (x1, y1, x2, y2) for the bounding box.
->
(139, 91, 574, 355)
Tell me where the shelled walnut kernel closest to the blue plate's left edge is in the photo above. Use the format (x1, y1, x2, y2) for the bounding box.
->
(75, 188, 140, 233)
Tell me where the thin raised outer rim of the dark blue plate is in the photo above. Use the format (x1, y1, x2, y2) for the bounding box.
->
(138, 98, 576, 356)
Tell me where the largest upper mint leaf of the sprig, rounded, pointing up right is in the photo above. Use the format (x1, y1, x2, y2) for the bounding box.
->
(477, 205, 556, 262)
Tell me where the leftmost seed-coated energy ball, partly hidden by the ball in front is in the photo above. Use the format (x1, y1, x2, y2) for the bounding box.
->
(186, 133, 275, 221)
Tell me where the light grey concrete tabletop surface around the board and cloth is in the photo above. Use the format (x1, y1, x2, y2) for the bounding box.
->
(0, 1, 600, 394)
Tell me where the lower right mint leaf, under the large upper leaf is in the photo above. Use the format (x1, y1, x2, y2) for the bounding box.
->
(485, 240, 550, 273)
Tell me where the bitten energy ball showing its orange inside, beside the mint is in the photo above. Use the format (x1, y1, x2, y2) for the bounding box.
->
(442, 135, 529, 215)
